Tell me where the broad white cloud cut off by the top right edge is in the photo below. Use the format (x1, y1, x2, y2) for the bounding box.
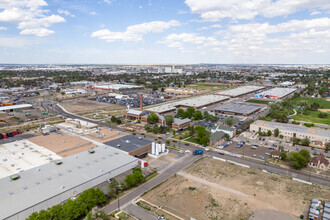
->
(185, 0, 330, 21)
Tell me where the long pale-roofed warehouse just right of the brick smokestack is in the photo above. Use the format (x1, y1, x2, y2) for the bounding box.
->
(145, 95, 229, 115)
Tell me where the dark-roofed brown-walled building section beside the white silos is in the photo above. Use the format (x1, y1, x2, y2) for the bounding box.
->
(104, 135, 152, 157)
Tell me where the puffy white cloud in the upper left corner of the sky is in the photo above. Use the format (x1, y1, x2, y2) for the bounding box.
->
(0, 0, 65, 36)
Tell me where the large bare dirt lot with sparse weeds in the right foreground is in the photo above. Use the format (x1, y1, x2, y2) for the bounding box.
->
(143, 158, 330, 220)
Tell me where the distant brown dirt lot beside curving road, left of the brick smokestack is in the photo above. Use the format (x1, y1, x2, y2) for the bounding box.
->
(61, 98, 126, 114)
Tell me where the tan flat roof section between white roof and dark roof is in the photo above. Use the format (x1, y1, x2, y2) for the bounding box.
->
(28, 133, 96, 157)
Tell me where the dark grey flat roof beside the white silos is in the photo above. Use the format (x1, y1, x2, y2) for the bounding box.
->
(105, 135, 152, 153)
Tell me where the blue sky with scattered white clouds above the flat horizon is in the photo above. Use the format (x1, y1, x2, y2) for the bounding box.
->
(0, 0, 330, 64)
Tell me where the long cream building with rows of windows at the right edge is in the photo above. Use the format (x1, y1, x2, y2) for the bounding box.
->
(250, 120, 330, 146)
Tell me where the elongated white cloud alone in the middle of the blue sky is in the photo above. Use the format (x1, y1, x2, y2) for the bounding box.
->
(91, 20, 180, 42)
